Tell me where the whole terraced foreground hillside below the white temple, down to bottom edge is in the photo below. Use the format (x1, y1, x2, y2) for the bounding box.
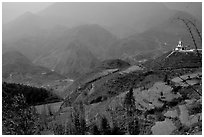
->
(4, 50, 202, 135)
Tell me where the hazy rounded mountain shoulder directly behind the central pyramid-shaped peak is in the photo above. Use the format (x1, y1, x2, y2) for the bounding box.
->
(59, 24, 117, 59)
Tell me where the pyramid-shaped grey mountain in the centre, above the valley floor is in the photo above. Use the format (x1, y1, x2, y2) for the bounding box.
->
(35, 41, 98, 77)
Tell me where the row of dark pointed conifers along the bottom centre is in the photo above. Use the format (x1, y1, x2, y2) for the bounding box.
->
(50, 88, 146, 135)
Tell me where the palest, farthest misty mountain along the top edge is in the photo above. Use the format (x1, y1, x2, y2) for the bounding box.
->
(39, 2, 172, 36)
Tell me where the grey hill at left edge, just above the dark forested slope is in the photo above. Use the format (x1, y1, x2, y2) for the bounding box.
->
(2, 51, 65, 86)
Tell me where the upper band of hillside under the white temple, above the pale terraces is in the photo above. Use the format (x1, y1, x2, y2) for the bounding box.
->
(60, 49, 202, 106)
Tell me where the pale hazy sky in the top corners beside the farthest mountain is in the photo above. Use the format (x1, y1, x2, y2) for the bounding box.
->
(2, 2, 202, 23)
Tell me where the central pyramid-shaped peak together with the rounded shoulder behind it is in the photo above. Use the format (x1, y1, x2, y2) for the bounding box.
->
(33, 25, 117, 77)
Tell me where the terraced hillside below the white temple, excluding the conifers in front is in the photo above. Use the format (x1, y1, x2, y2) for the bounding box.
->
(50, 49, 202, 135)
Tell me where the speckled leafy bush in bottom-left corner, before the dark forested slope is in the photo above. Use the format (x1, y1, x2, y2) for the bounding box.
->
(2, 85, 38, 135)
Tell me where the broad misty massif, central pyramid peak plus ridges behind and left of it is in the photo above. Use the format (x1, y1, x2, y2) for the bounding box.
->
(4, 22, 117, 77)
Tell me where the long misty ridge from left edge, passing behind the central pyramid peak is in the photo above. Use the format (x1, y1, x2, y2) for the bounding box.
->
(3, 21, 117, 60)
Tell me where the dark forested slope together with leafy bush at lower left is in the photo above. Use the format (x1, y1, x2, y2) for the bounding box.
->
(2, 82, 60, 135)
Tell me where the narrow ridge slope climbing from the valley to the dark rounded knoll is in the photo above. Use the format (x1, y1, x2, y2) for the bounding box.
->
(60, 59, 129, 102)
